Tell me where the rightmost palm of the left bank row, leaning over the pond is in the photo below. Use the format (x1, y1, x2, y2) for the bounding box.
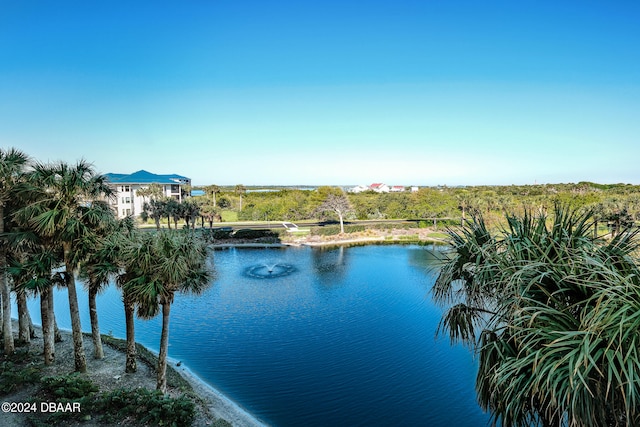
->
(123, 231, 209, 393)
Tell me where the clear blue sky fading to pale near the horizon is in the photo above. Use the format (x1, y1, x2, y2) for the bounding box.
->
(0, 0, 640, 185)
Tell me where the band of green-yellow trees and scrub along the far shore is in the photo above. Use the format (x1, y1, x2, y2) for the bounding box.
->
(188, 182, 640, 232)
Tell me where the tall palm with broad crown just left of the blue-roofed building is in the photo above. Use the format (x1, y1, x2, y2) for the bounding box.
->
(29, 160, 112, 372)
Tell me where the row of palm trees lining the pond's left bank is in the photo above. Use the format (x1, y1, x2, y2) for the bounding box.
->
(0, 148, 210, 392)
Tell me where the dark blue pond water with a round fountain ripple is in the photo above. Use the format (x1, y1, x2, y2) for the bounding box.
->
(22, 246, 488, 426)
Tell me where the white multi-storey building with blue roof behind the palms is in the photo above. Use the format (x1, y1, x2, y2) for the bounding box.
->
(106, 170, 191, 218)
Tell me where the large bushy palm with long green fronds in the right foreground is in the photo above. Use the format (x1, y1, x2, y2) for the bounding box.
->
(433, 206, 640, 426)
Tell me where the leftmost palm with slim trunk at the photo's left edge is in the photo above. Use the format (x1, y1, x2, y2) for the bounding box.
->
(0, 148, 29, 354)
